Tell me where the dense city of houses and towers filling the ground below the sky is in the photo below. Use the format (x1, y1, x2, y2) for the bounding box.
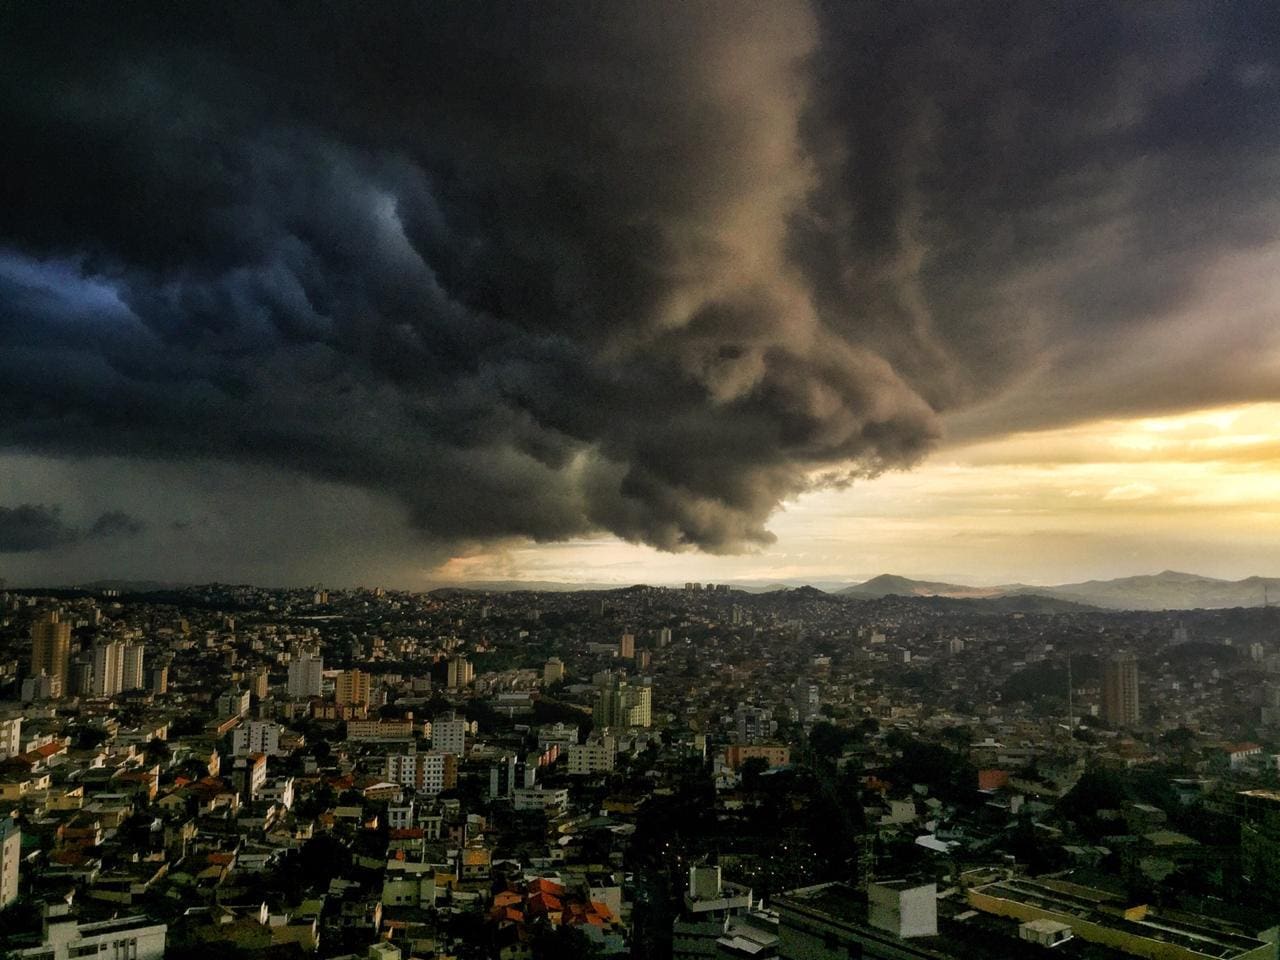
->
(0, 584, 1280, 960)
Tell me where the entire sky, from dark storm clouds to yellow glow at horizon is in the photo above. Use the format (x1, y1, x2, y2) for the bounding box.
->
(0, 0, 1280, 588)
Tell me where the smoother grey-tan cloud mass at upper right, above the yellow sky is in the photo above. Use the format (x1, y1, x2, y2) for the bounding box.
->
(792, 3, 1280, 434)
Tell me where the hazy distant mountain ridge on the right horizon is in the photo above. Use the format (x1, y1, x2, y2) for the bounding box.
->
(840, 570, 1280, 611)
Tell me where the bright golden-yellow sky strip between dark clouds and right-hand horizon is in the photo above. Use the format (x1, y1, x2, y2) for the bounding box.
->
(424, 403, 1280, 584)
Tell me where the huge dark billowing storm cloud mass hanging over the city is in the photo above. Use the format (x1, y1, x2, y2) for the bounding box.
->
(0, 3, 1280, 550)
